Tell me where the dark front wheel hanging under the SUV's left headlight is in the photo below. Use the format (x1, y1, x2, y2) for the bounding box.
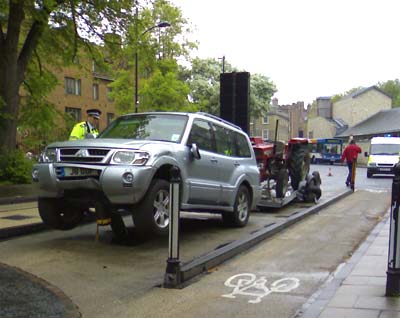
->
(38, 198, 83, 231)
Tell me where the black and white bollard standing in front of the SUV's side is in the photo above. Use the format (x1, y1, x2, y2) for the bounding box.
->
(164, 167, 181, 288)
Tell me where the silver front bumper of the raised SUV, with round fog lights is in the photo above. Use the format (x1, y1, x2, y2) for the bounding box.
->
(34, 163, 155, 204)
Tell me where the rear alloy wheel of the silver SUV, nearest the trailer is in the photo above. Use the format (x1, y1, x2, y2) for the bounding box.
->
(222, 185, 251, 227)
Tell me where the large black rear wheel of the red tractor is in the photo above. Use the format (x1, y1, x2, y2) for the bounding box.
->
(289, 145, 310, 190)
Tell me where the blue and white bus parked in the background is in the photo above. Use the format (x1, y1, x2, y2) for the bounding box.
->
(310, 138, 343, 165)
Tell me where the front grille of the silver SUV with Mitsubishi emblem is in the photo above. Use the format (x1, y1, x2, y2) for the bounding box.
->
(59, 148, 110, 163)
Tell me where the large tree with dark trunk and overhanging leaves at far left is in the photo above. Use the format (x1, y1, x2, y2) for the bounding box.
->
(0, 0, 132, 151)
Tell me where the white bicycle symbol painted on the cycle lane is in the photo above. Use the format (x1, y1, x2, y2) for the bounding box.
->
(222, 273, 300, 304)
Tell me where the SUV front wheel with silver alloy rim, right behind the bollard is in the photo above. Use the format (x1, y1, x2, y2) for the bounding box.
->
(133, 179, 169, 238)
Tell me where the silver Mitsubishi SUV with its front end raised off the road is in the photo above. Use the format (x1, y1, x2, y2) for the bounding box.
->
(33, 112, 260, 236)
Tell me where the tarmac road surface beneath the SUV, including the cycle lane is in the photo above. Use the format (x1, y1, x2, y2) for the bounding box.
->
(0, 163, 390, 317)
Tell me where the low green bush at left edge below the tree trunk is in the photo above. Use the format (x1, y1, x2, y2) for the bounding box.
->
(0, 150, 33, 184)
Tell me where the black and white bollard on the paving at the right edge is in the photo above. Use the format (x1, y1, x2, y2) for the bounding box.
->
(386, 163, 400, 296)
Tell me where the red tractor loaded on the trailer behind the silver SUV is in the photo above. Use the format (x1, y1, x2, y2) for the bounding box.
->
(250, 137, 321, 207)
